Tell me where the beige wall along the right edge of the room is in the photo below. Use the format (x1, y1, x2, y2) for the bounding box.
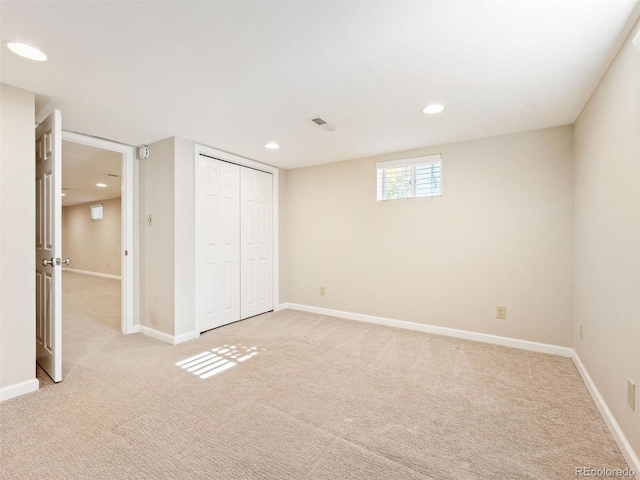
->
(572, 21, 640, 456)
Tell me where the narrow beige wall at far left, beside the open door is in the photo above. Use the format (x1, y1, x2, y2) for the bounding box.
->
(0, 84, 37, 390)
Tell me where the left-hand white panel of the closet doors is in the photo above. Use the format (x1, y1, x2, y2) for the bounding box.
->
(196, 156, 240, 332)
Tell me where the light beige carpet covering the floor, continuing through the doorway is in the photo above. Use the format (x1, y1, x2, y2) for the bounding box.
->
(0, 273, 627, 480)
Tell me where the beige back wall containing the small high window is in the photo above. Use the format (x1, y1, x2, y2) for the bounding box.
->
(281, 126, 572, 346)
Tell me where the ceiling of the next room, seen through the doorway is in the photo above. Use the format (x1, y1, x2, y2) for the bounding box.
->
(62, 141, 122, 207)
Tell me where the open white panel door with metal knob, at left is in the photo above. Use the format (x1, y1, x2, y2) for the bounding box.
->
(36, 110, 62, 382)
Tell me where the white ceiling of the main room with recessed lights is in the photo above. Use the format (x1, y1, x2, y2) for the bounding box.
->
(0, 0, 639, 168)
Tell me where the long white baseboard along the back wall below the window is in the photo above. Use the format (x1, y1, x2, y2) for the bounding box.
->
(277, 303, 573, 357)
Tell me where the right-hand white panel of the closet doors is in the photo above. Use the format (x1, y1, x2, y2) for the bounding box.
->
(240, 167, 273, 319)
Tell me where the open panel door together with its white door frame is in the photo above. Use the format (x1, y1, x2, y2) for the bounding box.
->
(34, 110, 137, 383)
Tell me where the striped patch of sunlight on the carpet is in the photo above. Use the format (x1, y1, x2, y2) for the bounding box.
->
(176, 345, 258, 379)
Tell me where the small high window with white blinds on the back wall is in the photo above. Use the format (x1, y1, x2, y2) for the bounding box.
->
(376, 155, 442, 202)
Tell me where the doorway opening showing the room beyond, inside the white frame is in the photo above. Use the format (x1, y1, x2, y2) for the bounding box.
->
(61, 140, 124, 338)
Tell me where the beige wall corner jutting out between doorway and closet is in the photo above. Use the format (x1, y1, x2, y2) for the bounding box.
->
(140, 137, 195, 336)
